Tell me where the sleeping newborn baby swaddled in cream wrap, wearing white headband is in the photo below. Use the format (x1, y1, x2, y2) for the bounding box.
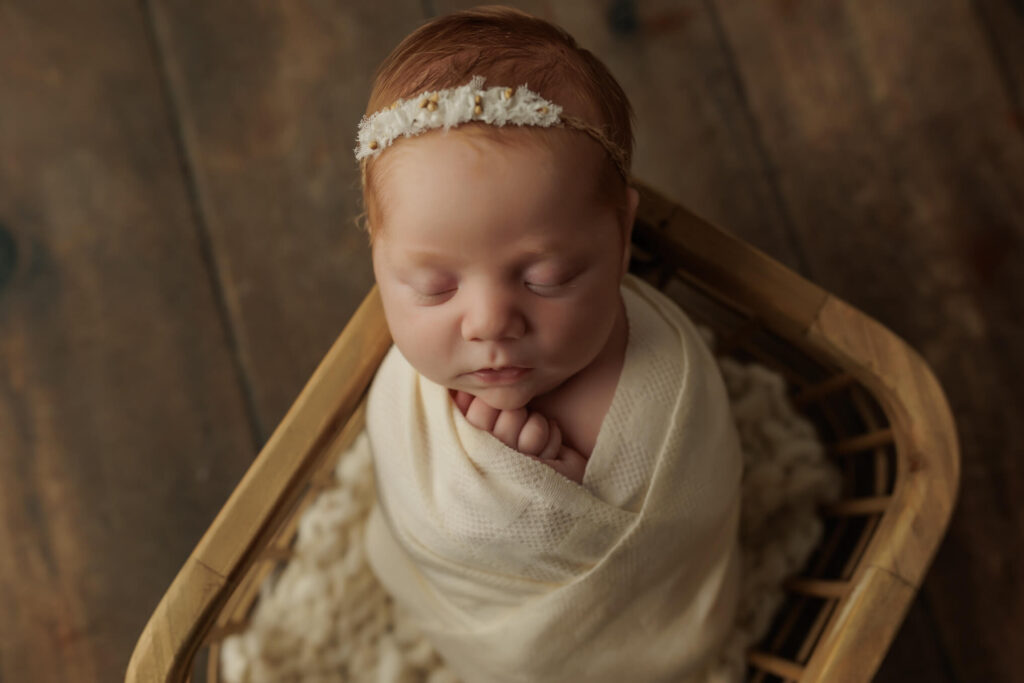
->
(356, 8, 740, 681)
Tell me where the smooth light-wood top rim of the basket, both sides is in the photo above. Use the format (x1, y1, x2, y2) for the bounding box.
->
(126, 183, 959, 681)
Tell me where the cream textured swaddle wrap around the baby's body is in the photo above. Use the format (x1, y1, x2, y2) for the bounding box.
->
(366, 275, 742, 683)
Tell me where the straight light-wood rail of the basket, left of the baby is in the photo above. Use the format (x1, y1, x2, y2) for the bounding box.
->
(125, 287, 391, 683)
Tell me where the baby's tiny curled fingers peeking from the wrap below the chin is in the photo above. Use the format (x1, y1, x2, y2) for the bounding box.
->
(451, 391, 587, 483)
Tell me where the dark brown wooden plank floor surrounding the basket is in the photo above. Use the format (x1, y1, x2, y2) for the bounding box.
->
(0, 0, 1024, 683)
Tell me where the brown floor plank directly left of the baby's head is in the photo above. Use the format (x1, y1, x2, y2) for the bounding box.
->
(144, 0, 423, 432)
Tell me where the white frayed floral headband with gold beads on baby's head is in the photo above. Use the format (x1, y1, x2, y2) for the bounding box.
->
(355, 76, 630, 181)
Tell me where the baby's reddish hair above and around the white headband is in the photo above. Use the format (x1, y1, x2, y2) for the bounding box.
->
(361, 5, 634, 240)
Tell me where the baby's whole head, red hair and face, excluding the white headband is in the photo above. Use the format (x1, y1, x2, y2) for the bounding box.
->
(361, 7, 637, 409)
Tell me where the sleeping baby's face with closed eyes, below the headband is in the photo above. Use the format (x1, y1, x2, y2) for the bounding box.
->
(373, 129, 636, 410)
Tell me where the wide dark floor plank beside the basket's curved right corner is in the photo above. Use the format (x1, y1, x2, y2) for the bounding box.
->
(716, 1, 1024, 681)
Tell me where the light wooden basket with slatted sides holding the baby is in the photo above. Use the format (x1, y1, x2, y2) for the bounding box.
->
(127, 187, 959, 683)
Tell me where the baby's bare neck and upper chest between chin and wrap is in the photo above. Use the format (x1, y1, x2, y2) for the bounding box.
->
(527, 296, 629, 458)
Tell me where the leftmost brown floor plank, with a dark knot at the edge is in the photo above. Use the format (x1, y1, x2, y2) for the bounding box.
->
(0, 0, 255, 683)
